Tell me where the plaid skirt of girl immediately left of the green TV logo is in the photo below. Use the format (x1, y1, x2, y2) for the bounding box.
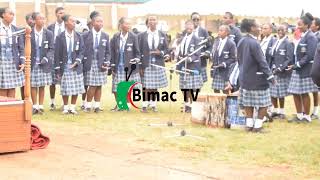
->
(84, 60, 107, 86)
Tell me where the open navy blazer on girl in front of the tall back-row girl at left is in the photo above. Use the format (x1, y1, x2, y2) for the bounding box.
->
(54, 31, 84, 76)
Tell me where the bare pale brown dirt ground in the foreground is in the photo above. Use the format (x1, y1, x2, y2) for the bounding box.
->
(0, 121, 295, 180)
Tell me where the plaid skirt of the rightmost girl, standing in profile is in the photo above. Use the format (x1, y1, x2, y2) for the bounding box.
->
(288, 71, 318, 94)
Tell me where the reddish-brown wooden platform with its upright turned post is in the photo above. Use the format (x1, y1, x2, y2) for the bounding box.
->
(0, 27, 32, 153)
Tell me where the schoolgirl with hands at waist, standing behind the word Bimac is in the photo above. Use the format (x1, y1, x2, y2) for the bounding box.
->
(138, 16, 169, 113)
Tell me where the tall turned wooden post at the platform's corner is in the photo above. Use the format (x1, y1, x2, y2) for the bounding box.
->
(24, 26, 32, 121)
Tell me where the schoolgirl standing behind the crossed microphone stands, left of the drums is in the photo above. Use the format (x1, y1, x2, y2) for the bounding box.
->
(177, 20, 203, 113)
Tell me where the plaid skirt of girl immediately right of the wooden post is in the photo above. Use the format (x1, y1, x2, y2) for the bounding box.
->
(31, 66, 52, 87)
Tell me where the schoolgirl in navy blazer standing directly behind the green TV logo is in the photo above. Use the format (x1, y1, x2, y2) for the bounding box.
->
(110, 17, 141, 111)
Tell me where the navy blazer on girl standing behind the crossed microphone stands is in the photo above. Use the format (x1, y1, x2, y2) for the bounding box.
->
(177, 35, 201, 72)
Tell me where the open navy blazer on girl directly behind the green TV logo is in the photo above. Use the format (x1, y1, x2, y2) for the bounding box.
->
(110, 32, 141, 74)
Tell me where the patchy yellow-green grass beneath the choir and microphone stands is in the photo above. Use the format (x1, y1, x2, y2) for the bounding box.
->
(34, 63, 320, 178)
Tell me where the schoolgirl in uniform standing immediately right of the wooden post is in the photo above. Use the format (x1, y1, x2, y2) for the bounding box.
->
(31, 12, 54, 114)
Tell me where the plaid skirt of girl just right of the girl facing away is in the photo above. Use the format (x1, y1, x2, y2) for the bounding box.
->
(270, 75, 291, 98)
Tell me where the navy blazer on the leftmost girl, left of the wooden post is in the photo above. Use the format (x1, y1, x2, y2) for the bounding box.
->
(0, 25, 26, 70)
